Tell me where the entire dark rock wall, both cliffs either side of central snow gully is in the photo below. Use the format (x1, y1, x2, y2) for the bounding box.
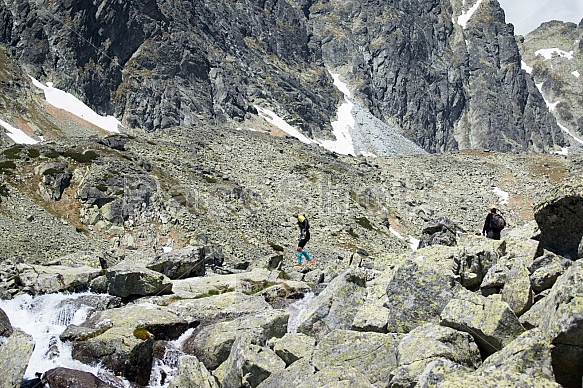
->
(0, 0, 565, 152)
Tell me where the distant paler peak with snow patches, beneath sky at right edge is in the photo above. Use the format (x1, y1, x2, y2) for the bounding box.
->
(519, 20, 583, 139)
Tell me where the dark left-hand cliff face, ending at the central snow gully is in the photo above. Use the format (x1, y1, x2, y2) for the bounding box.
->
(0, 0, 340, 134)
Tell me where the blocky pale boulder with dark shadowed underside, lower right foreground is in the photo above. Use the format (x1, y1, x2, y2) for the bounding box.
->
(440, 290, 525, 357)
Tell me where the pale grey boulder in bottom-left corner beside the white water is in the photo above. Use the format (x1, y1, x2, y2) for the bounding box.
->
(0, 328, 35, 388)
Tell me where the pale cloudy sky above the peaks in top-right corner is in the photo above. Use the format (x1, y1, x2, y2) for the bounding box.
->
(498, 0, 583, 35)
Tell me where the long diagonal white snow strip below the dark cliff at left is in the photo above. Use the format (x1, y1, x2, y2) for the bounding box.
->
(29, 76, 121, 133)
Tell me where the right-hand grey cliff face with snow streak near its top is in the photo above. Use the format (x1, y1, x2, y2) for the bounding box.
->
(312, 0, 563, 152)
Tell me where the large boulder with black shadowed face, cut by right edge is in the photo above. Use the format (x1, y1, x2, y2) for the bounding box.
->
(534, 172, 583, 260)
